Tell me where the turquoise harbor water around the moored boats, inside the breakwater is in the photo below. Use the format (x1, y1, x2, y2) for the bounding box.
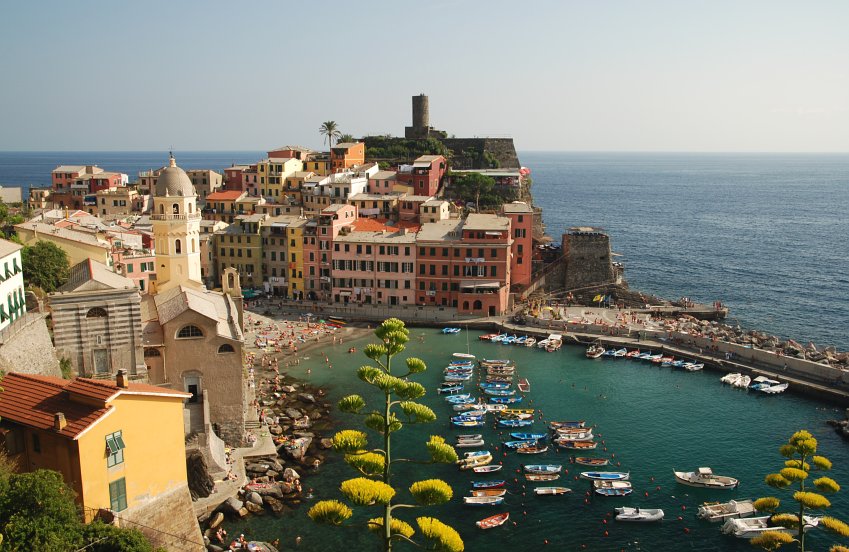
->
(233, 328, 849, 552)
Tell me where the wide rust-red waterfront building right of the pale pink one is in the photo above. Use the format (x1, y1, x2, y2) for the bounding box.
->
(416, 214, 512, 315)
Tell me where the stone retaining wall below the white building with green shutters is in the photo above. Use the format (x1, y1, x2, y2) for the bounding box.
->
(0, 312, 62, 377)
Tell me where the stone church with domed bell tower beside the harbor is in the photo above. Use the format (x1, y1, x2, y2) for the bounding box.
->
(50, 156, 253, 449)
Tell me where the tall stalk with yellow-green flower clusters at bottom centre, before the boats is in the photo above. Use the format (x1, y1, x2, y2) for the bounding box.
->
(308, 318, 464, 552)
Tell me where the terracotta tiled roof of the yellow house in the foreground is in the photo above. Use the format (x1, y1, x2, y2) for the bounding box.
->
(0, 372, 191, 439)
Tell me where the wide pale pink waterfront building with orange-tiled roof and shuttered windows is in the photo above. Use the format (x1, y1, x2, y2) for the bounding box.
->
(332, 219, 416, 305)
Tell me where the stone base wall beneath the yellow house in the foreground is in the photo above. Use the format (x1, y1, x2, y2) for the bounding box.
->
(116, 483, 206, 552)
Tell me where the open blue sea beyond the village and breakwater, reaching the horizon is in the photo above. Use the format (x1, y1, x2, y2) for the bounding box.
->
(0, 151, 849, 349)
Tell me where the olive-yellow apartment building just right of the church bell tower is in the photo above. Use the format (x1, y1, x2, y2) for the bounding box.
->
(215, 213, 269, 288)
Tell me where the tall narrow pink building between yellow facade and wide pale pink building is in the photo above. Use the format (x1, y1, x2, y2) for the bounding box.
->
(304, 203, 357, 301)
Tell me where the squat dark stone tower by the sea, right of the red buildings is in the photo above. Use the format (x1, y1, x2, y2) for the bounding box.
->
(563, 226, 621, 294)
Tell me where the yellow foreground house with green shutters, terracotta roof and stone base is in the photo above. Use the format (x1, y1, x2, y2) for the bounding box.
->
(0, 371, 203, 550)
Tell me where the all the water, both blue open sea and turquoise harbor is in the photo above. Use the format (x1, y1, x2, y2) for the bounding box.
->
(0, 152, 849, 552)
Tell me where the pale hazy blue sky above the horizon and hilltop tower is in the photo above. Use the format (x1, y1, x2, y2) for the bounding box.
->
(0, 0, 849, 152)
